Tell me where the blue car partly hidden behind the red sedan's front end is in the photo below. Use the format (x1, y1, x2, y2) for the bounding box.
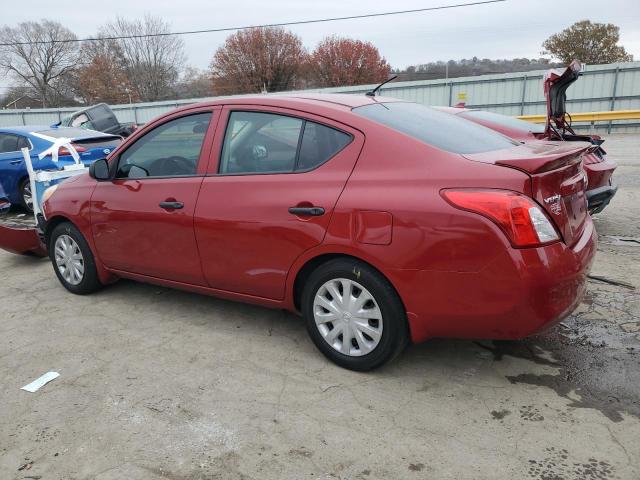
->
(0, 125, 122, 212)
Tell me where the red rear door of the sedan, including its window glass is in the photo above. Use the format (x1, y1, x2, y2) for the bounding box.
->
(195, 106, 364, 299)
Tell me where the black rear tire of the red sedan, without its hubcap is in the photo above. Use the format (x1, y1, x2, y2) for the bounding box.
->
(301, 258, 409, 371)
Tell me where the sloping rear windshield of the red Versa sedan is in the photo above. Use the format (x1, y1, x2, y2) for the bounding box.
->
(353, 102, 519, 154)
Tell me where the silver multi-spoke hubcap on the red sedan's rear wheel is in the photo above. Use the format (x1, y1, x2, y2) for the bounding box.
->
(313, 278, 383, 357)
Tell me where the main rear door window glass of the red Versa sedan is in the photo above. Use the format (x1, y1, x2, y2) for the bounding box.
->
(219, 112, 303, 173)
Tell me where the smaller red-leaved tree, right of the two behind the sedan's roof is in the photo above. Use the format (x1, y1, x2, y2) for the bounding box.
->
(309, 36, 391, 87)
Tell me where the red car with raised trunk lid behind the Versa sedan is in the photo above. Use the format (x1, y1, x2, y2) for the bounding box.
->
(437, 62, 618, 214)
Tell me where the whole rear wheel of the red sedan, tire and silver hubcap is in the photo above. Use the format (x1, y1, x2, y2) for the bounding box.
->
(301, 258, 408, 371)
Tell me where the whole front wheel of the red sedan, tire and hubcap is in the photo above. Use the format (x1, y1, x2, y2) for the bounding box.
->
(49, 222, 102, 295)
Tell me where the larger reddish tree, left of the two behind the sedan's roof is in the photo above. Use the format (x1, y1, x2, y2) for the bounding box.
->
(211, 27, 307, 94)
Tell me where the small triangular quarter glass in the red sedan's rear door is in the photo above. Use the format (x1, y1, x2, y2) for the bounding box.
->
(296, 121, 352, 170)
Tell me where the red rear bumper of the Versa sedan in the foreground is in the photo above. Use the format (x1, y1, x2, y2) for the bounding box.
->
(394, 218, 597, 342)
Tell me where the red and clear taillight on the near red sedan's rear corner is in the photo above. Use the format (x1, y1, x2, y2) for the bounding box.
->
(442, 189, 559, 247)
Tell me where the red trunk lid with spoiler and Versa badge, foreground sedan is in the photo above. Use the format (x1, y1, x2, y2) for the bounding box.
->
(465, 142, 593, 246)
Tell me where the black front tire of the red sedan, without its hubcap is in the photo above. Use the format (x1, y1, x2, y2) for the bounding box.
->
(49, 222, 102, 295)
